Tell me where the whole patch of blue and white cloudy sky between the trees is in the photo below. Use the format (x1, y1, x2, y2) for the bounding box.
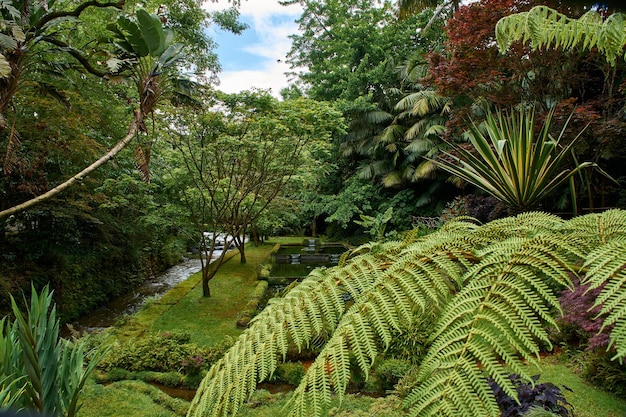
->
(205, 0, 302, 96)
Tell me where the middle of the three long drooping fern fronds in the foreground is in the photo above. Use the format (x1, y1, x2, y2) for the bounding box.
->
(287, 218, 488, 417)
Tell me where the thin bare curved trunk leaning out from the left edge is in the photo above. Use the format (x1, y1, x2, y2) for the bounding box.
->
(0, 110, 143, 220)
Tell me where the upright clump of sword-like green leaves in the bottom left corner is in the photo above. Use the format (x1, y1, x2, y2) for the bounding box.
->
(0, 287, 106, 417)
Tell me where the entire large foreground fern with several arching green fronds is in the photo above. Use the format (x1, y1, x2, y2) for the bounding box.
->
(188, 210, 626, 417)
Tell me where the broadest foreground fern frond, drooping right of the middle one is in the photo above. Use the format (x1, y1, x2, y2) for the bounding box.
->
(406, 235, 569, 417)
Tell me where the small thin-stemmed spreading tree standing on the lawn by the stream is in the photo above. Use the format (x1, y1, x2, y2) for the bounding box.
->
(166, 92, 341, 296)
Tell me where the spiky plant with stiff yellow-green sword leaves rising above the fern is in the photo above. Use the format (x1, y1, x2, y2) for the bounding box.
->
(434, 107, 597, 213)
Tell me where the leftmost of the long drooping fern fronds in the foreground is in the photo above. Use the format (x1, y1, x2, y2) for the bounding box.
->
(188, 247, 385, 416)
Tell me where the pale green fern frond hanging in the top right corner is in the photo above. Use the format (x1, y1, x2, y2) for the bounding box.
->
(496, 6, 626, 65)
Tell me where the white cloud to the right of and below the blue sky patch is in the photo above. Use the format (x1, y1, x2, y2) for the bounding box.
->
(204, 0, 302, 96)
